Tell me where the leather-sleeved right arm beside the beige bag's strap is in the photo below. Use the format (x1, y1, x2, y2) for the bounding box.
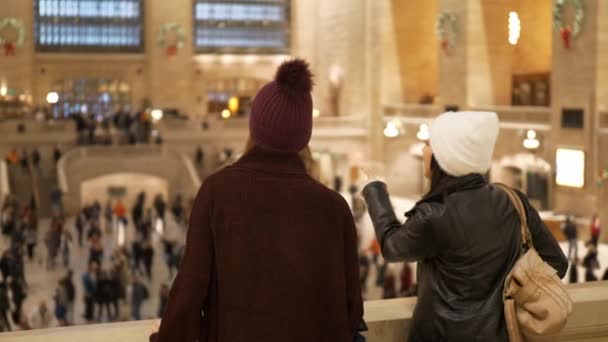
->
(517, 191, 568, 278)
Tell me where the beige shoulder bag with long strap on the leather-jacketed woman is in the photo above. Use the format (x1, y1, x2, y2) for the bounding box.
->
(496, 184, 572, 342)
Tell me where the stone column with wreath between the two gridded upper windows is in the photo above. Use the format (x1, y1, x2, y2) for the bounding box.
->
(145, 0, 195, 117)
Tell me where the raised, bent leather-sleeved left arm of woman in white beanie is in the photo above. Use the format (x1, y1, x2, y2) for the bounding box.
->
(363, 181, 436, 262)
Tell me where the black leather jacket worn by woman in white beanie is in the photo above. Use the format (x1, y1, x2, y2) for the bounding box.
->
(363, 174, 568, 342)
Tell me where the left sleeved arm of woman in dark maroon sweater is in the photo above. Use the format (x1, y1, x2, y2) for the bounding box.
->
(150, 179, 215, 342)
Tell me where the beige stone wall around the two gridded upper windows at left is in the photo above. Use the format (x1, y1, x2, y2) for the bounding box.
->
(0, 0, 367, 117)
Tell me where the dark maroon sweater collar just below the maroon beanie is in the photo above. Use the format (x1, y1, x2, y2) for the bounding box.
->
(234, 146, 306, 174)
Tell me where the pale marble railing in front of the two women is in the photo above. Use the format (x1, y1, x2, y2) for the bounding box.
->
(0, 282, 608, 342)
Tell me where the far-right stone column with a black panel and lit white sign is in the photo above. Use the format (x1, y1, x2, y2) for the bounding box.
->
(551, 0, 606, 222)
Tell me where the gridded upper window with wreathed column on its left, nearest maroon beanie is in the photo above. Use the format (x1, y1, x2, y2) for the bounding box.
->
(194, 0, 290, 53)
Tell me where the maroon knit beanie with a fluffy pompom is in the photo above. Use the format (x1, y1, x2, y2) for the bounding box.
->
(249, 59, 313, 152)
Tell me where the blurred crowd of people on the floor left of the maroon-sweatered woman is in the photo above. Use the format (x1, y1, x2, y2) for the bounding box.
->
(0, 188, 189, 331)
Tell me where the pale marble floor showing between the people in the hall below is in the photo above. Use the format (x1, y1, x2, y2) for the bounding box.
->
(0, 198, 608, 332)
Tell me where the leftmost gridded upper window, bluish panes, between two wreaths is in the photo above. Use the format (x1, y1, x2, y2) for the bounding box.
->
(34, 0, 143, 52)
